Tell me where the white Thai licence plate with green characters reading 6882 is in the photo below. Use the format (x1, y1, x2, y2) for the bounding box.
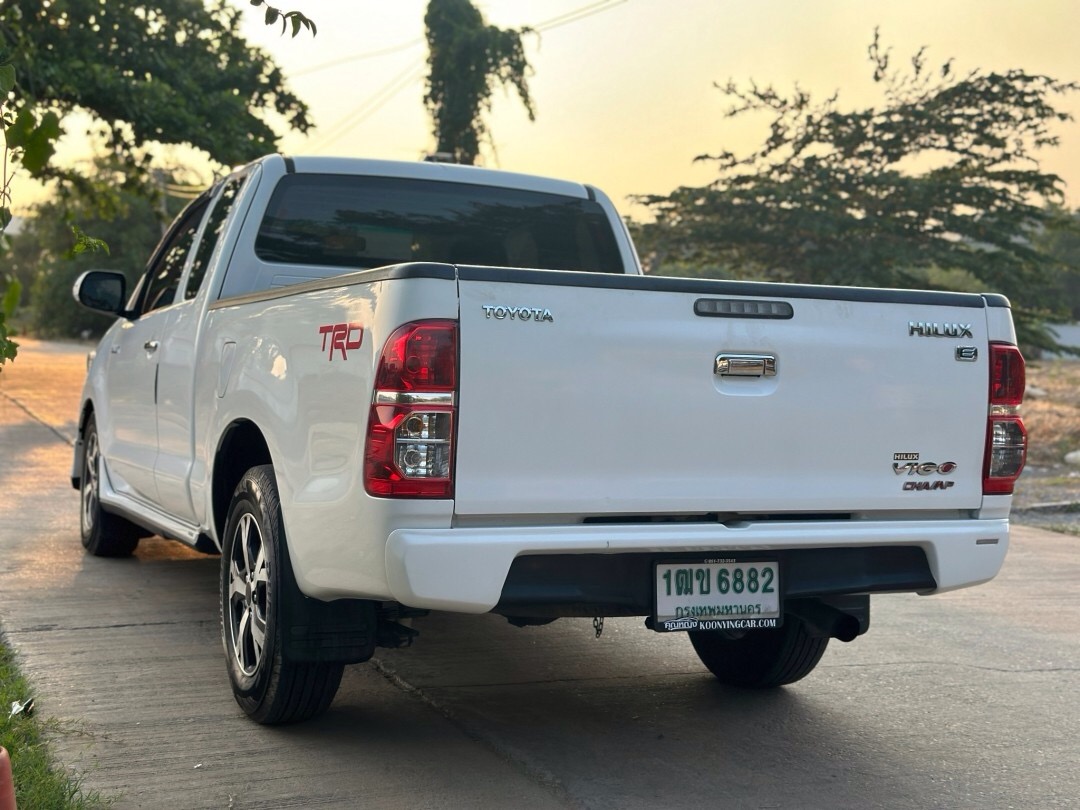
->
(652, 559, 783, 633)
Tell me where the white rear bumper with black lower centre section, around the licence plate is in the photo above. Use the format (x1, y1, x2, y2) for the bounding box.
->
(386, 519, 1009, 616)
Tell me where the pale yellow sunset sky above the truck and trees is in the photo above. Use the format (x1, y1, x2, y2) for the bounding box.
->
(10, 0, 1080, 219)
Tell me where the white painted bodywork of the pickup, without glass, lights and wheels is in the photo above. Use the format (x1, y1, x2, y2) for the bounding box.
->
(83, 157, 1015, 612)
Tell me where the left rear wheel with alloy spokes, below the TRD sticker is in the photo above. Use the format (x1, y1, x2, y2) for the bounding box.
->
(220, 464, 345, 725)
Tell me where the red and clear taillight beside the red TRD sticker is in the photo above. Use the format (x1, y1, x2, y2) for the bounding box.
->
(364, 321, 458, 498)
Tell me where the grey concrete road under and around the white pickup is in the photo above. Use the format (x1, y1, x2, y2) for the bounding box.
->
(0, 341, 1080, 810)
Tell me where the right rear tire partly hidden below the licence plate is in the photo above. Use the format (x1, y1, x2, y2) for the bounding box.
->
(690, 617, 828, 689)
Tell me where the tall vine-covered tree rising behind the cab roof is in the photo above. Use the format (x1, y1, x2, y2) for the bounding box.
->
(423, 0, 536, 164)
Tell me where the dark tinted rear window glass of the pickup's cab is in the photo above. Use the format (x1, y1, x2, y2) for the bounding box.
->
(255, 175, 622, 273)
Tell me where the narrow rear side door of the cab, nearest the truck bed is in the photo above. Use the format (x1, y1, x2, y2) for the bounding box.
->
(154, 173, 257, 523)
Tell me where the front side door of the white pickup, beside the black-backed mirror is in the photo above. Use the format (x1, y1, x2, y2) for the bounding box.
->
(98, 195, 210, 504)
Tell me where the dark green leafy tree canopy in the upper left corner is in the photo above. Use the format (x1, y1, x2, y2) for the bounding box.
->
(0, 0, 314, 177)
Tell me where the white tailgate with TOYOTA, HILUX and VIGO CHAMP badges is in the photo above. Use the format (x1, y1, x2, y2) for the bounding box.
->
(455, 267, 988, 519)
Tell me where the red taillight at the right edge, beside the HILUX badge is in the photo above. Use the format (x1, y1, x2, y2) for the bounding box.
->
(983, 343, 1027, 495)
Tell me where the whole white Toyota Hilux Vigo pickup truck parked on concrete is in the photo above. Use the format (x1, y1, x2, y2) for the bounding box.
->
(72, 156, 1026, 723)
